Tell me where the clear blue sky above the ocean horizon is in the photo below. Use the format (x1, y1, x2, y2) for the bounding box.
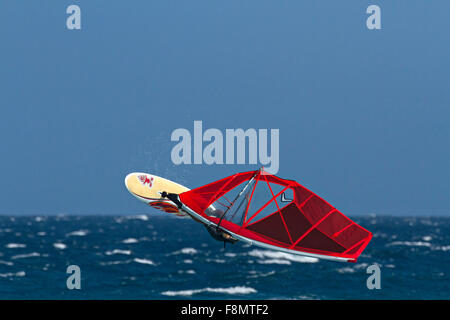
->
(0, 0, 450, 216)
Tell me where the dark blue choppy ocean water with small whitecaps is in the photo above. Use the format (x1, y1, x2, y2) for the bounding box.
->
(0, 214, 450, 299)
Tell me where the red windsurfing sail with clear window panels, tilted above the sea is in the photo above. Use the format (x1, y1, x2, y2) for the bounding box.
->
(179, 169, 372, 262)
